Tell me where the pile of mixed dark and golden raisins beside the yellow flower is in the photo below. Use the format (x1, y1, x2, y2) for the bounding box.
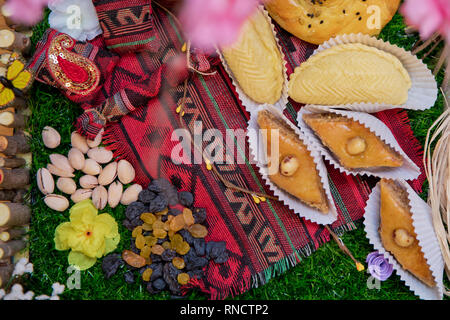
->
(102, 179, 228, 296)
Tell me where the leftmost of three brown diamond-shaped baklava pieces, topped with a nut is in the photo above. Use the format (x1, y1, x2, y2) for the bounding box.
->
(258, 110, 329, 213)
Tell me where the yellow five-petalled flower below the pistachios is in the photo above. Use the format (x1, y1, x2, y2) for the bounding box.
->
(54, 200, 120, 270)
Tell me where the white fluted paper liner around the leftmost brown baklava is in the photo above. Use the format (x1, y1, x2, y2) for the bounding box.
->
(247, 105, 338, 225)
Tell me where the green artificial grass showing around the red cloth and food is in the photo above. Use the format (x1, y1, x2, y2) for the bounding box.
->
(25, 14, 443, 300)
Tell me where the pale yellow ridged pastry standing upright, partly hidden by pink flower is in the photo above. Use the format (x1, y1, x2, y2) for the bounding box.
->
(222, 10, 284, 104)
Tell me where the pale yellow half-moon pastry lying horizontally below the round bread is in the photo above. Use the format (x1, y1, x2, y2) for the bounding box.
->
(289, 43, 411, 105)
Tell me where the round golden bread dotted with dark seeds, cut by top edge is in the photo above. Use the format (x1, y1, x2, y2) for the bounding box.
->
(265, 0, 400, 44)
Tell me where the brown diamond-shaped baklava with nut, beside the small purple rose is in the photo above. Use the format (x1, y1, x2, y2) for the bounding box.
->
(379, 179, 436, 287)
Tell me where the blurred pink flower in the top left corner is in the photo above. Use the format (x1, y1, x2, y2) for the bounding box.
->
(5, 0, 51, 25)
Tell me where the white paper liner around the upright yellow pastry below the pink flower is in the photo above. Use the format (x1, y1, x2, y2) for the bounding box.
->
(217, 6, 289, 112)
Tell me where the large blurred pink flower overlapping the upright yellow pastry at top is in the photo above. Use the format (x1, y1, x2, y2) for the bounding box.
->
(180, 0, 261, 50)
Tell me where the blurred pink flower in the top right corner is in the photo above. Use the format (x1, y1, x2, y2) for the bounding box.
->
(401, 0, 450, 41)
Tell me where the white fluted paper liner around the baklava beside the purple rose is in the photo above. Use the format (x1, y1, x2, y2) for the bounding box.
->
(364, 180, 444, 300)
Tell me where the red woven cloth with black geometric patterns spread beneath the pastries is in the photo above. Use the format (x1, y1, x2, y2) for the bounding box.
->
(104, 6, 424, 299)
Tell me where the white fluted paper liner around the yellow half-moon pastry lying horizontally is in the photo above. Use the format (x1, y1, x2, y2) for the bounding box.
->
(292, 33, 438, 113)
